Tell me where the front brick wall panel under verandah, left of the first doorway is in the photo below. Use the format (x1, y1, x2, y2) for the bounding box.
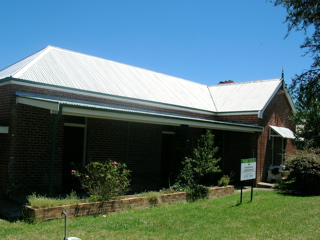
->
(8, 105, 51, 191)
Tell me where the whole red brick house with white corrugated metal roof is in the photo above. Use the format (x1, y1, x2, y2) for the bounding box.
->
(0, 46, 295, 194)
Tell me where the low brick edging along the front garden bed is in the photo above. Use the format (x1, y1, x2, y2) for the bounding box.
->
(23, 186, 234, 223)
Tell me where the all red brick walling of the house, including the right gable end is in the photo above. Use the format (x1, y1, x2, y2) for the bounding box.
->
(0, 81, 294, 194)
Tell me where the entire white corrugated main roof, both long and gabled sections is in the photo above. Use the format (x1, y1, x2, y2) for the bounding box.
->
(0, 46, 281, 113)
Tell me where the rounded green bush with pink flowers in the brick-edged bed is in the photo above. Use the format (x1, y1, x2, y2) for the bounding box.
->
(72, 160, 130, 201)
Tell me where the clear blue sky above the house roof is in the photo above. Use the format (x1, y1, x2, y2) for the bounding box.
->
(0, 0, 312, 85)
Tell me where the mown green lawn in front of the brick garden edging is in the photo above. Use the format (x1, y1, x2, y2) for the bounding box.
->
(0, 191, 320, 240)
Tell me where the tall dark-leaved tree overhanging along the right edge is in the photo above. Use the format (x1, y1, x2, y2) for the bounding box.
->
(271, 0, 320, 147)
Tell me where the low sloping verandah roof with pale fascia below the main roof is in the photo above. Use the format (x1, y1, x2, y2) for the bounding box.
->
(16, 92, 263, 132)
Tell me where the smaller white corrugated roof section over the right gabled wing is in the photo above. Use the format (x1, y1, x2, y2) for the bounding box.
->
(209, 78, 282, 113)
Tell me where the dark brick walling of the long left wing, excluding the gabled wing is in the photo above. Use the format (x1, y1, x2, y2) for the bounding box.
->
(0, 81, 212, 192)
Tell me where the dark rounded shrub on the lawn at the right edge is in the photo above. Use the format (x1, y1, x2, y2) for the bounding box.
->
(280, 149, 320, 195)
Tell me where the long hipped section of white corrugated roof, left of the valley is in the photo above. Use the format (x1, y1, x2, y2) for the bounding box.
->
(0, 46, 215, 111)
